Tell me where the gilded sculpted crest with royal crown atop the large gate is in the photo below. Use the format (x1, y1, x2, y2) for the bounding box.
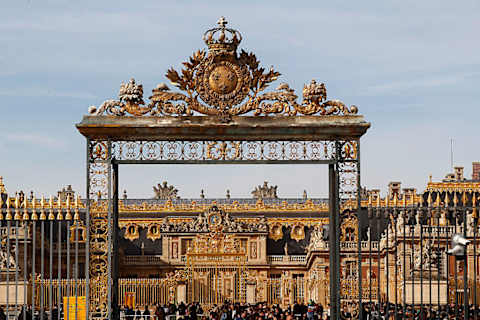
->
(89, 17, 358, 119)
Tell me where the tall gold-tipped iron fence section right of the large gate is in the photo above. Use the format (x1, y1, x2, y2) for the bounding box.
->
(359, 194, 479, 319)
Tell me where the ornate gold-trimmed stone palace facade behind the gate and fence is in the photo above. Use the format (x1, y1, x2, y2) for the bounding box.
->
(0, 163, 480, 307)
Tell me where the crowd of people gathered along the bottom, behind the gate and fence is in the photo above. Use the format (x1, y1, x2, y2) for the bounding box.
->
(0, 301, 480, 320)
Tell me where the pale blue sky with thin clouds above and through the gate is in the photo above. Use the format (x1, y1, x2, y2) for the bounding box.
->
(0, 0, 480, 198)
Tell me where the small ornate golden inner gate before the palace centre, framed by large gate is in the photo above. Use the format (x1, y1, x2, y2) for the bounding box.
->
(186, 206, 247, 309)
